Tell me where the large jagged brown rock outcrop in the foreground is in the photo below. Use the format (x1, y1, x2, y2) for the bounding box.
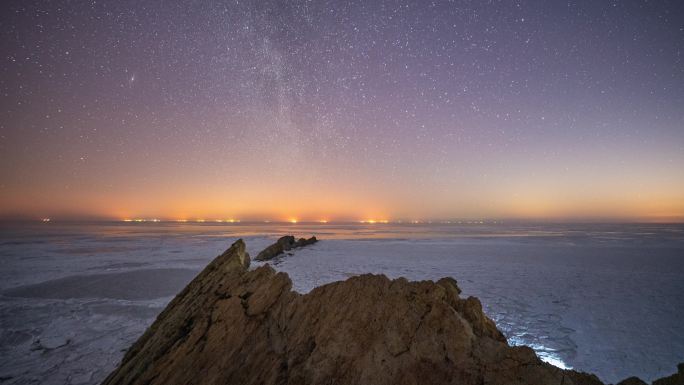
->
(104, 240, 680, 385)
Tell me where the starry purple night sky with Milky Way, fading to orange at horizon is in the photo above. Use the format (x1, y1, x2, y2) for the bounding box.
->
(0, 0, 684, 221)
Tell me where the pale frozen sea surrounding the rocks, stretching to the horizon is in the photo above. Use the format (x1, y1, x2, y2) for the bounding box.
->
(0, 222, 684, 385)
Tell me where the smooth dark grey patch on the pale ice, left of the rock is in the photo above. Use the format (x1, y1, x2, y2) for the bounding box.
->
(3, 269, 197, 300)
